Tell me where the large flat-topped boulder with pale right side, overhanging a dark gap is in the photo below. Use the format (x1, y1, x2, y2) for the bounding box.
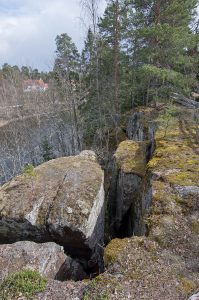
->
(0, 151, 104, 269)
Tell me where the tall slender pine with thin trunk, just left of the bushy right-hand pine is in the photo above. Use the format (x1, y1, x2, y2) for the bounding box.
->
(99, 0, 127, 115)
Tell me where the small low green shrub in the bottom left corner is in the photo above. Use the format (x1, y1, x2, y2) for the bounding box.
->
(0, 270, 47, 300)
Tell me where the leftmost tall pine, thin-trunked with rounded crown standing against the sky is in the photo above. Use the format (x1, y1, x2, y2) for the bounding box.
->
(54, 33, 81, 153)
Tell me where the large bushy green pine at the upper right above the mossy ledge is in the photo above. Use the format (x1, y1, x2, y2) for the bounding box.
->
(128, 0, 198, 104)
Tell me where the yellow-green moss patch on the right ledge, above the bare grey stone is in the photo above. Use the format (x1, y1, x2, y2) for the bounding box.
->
(148, 127, 199, 186)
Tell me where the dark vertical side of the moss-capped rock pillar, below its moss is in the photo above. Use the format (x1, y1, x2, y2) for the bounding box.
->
(109, 171, 152, 237)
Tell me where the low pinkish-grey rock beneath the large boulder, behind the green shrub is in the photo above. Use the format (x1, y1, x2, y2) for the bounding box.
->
(0, 241, 86, 282)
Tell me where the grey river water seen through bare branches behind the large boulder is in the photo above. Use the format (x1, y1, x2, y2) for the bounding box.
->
(0, 111, 81, 185)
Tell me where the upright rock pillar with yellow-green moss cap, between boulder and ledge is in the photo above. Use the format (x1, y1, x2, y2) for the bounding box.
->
(108, 140, 152, 237)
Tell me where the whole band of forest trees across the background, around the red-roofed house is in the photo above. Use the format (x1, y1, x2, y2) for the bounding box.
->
(0, 0, 199, 166)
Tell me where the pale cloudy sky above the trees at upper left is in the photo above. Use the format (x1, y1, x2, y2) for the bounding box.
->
(0, 0, 105, 70)
